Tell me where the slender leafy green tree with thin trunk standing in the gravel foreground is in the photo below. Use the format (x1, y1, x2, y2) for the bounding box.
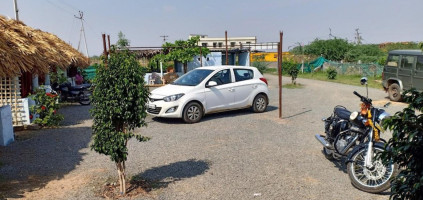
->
(91, 49, 149, 194)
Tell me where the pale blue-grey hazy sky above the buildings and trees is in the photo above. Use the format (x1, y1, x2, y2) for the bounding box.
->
(0, 0, 423, 56)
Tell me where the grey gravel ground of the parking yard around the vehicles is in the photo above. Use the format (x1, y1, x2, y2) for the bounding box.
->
(0, 75, 405, 199)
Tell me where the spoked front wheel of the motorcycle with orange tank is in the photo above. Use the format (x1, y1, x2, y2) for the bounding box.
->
(347, 144, 398, 193)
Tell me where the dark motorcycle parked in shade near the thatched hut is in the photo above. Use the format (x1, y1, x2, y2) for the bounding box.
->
(52, 83, 91, 105)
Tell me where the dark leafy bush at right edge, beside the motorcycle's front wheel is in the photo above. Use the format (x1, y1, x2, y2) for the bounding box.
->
(381, 89, 423, 200)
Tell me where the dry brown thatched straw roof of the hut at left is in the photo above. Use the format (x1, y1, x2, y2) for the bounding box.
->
(0, 16, 89, 77)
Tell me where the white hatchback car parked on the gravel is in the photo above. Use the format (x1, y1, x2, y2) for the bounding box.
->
(147, 66, 269, 123)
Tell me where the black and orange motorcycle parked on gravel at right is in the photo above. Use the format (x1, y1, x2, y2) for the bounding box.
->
(316, 77, 397, 193)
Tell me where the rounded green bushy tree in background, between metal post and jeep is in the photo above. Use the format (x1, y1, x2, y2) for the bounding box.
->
(304, 39, 352, 60)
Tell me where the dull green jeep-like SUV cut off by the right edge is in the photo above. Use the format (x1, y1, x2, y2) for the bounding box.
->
(382, 50, 423, 101)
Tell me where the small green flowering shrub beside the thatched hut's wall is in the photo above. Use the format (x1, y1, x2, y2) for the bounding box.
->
(30, 86, 64, 126)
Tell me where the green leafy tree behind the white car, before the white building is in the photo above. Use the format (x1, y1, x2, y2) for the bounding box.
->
(153, 36, 210, 73)
